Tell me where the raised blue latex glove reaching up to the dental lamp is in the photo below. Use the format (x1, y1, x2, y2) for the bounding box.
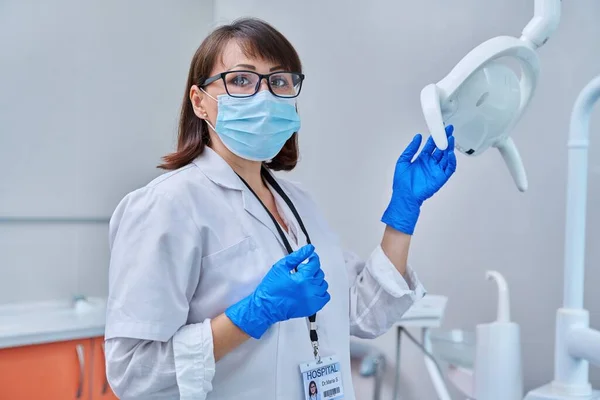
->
(381, 125, 456, 235)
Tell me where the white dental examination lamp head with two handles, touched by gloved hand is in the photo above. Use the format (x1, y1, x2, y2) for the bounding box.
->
(421, 0, 561, 192)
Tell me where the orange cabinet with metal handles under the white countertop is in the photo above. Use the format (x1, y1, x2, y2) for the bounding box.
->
(0, 337, 117, 400)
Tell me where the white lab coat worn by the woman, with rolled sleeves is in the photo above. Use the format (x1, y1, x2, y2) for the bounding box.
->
(106, 148, 425, 400)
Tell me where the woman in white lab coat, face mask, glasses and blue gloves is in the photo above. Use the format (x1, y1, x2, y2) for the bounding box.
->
(105, 19, 456, 400)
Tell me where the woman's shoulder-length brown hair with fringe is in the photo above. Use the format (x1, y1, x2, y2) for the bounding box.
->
(159, 18, 302, 171)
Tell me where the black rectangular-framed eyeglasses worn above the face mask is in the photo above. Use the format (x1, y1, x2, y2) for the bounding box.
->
(202, 71, 304, 98)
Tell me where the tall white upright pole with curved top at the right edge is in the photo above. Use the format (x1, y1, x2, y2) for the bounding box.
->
(525, 75, 600, 400)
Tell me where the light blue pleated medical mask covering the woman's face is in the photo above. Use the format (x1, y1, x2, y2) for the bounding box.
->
(202, 90, 300, 161)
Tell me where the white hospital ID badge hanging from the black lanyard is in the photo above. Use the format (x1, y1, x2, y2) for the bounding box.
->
(300, 356, 344, 400)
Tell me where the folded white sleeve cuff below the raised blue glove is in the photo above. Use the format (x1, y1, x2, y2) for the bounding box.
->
(367, 245, 426, 300)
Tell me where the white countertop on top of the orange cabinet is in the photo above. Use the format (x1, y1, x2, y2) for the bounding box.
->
(0, 298, 106, 348)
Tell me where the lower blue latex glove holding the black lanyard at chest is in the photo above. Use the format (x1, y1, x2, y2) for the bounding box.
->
(225, 245, 331, 339)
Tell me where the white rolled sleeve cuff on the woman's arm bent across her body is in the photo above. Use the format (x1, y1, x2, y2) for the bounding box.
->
(173, 319, 215, 400)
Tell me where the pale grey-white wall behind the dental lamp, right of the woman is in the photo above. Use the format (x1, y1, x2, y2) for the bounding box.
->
(215, 0, 600, 400)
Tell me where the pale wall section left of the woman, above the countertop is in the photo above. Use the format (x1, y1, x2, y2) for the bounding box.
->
(0, 0, 213, 303)
